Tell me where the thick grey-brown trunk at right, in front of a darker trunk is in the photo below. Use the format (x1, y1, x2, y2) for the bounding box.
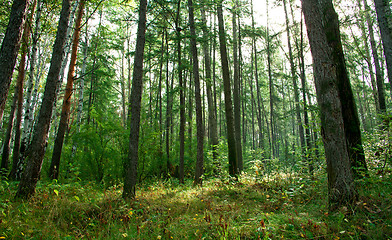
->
(302, 0, 357, 209)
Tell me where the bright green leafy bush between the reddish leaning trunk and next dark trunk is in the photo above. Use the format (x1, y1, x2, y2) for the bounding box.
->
(69, 109, 127, 186)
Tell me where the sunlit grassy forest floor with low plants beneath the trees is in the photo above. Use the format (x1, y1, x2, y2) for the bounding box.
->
(0, 172, 392, 239)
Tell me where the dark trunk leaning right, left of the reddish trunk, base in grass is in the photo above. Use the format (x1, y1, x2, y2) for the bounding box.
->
(16, 0, 71, 198)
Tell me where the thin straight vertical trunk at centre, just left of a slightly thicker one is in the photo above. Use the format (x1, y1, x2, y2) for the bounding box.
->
(176, 0, 186, 183)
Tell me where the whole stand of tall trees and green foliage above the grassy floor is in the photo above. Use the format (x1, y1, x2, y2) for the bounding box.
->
(0, 0, 392, 208)
